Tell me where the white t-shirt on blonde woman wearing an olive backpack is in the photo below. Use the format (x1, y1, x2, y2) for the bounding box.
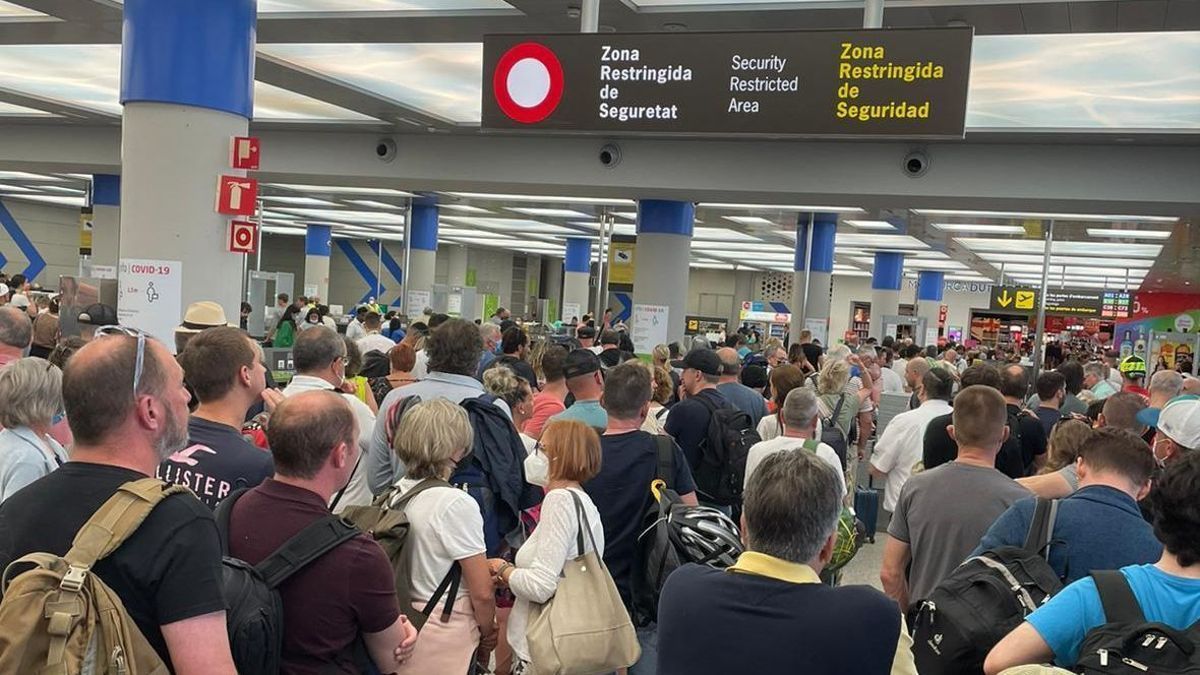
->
(396, 478, 487, 603)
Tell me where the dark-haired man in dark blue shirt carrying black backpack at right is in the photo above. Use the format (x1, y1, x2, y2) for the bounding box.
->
(971, 428, 1163, 584)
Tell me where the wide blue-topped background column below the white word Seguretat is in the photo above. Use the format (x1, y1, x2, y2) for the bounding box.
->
(619, 199, 696, 345)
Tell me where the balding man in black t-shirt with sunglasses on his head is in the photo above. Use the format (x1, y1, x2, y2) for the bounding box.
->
(0, 335, 236, 675)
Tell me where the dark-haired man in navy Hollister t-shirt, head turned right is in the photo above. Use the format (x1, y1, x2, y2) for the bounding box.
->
(158, 327, 274, 508)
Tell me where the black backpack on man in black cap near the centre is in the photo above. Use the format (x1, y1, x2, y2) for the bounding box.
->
(692, 396, 762, 506)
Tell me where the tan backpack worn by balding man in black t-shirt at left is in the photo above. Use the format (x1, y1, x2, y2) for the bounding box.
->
(0, 478, 180, 675)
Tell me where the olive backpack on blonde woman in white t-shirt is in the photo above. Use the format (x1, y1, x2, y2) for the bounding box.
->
(342, 478, 462, 631)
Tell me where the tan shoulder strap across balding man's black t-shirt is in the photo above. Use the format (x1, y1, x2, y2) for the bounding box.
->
(64, 478, 187, 571)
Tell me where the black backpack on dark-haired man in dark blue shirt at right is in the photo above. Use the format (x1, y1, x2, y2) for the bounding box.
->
(910, 498, 1062, 675)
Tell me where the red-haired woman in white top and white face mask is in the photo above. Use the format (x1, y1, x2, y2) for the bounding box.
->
(487, 420, 604, 675)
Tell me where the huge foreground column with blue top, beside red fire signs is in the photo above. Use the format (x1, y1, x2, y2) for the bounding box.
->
(117, 0, 257, 348)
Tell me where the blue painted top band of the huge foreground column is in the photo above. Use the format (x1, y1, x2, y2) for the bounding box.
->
(121, 0, 257, 119)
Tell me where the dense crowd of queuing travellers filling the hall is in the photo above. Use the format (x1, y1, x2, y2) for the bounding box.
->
(0, 295, 1200, 675)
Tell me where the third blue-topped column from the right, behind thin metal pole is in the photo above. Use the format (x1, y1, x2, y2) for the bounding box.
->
(788, 213, 838, 345)
